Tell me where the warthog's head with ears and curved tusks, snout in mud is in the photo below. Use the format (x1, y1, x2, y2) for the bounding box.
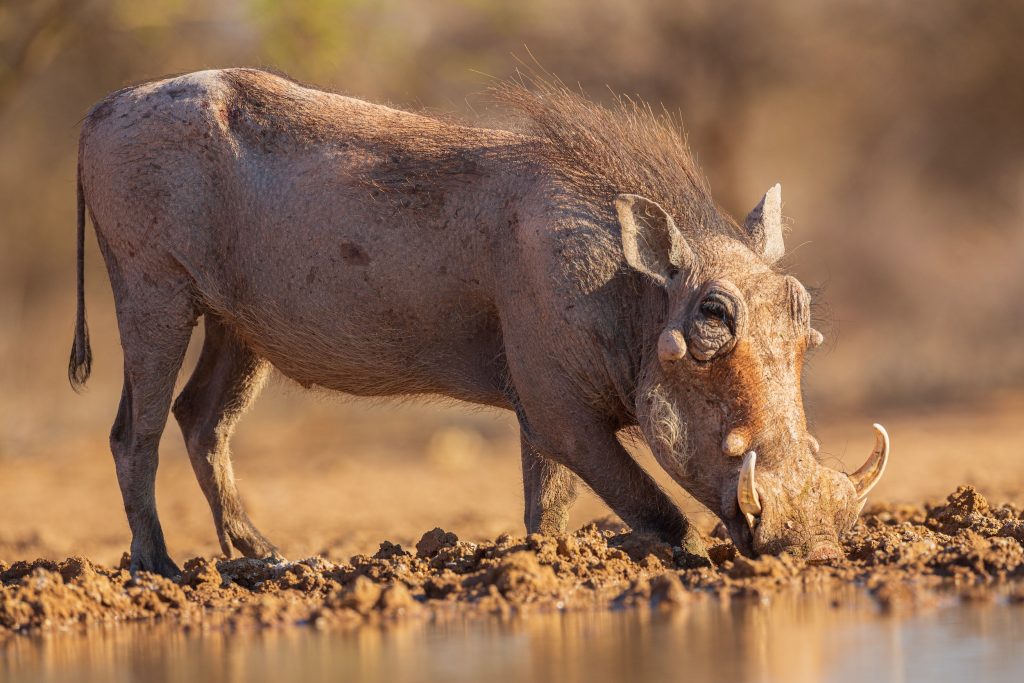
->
(615, 185, 889, 561)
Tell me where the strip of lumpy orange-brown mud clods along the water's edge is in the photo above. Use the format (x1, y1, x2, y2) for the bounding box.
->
(0, 486, 1024, 636)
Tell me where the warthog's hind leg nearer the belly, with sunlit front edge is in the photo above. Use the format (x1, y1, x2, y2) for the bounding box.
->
(173, 314, 281, 557)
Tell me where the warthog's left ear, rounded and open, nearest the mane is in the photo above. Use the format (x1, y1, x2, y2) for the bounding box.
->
(615, 195, 693, 285)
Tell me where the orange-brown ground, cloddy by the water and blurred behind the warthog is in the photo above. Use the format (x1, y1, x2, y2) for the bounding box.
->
(0, 366, 1024, 636)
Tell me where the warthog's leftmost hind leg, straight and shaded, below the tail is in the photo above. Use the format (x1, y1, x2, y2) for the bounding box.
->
(111, 278, 196, 577)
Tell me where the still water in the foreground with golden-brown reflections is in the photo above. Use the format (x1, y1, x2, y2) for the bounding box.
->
(6, 591, 1024, 683)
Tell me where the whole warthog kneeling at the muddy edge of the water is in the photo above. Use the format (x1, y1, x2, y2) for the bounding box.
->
(69, 69, 889, 575)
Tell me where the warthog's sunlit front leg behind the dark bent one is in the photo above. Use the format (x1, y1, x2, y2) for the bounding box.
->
(519, 431, 580, 536)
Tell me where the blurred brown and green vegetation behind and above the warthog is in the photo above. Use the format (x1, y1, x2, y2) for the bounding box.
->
(0, 0, 1024, 404)
